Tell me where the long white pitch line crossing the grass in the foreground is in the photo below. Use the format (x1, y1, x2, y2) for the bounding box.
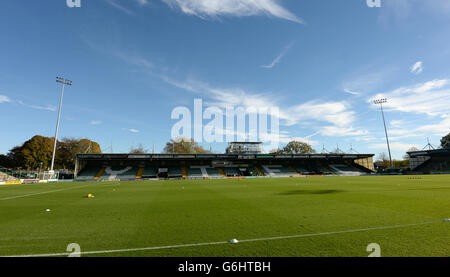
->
(6, 220, 445, 258)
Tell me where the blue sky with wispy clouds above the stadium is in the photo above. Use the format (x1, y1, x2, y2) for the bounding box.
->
(0, 0, 450, 158)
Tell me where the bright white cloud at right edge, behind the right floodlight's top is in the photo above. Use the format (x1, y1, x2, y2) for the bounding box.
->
(368, 79, 450, 116)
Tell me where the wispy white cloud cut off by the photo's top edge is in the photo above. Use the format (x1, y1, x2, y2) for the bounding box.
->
(162, 0, 304, 23)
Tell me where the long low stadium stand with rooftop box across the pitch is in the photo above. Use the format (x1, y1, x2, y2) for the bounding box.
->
(75, 142, 374, 181)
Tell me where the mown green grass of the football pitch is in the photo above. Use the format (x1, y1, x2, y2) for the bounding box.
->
(0, 175, 450, 257)
